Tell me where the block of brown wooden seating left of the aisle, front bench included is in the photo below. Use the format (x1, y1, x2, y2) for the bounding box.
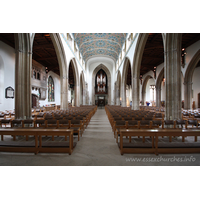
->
(0, 106, 97, 154)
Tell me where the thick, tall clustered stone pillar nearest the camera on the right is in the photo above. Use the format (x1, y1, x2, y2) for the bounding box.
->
(165, 33, 182, 120)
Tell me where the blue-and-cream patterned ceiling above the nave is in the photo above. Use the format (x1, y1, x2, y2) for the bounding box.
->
(73, 33, 127, 61)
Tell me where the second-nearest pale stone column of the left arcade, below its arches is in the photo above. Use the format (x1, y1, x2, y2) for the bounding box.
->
(60, 76, 68, 110)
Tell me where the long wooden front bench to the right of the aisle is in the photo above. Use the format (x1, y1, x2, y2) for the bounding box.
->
(119, 129, 200, 155)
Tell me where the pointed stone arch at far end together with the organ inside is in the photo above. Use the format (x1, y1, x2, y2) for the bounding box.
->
(92, 64, 111, 105)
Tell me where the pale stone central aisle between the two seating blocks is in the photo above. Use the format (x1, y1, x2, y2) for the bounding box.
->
(72, 109, 124, 165)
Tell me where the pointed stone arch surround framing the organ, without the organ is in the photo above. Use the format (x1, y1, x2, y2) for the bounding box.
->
(92, 64, 111, 105)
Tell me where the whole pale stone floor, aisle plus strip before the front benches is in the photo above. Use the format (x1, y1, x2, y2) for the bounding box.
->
(0, 109, 200, 166)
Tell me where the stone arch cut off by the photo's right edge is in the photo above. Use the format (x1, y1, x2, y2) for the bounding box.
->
(184, 49, 200, 110)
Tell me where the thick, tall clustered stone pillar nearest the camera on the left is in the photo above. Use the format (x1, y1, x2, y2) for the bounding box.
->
(15, 33, 32, 119)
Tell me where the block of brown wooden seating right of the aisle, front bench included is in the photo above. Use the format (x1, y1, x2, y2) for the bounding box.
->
(105, 106, 200, 155)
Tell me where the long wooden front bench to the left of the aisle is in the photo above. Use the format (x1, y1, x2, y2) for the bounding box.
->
(0, 128, 75, 155)
